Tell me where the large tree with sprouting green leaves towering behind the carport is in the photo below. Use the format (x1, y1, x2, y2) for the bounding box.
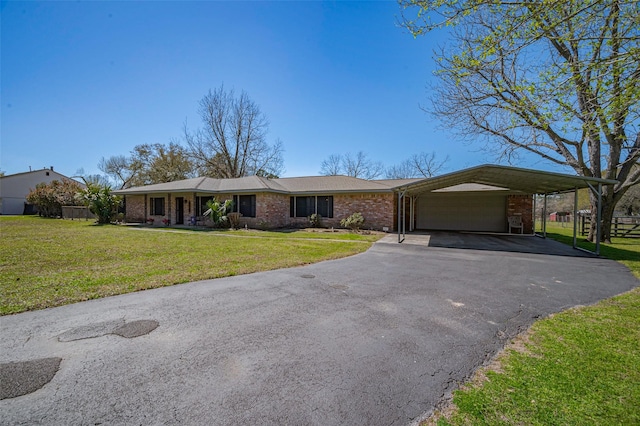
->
(400, 0, 640, 241)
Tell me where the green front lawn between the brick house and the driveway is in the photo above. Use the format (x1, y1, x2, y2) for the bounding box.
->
(0, 216, 380, 315)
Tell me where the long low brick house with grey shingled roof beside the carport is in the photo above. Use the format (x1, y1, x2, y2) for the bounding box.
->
(114, 176, 410, 230)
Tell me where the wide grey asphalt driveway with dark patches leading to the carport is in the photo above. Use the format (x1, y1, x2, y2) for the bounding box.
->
(0, 235, 639, 425)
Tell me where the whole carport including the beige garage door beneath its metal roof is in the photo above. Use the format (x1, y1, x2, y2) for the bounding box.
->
(394, 165, 617, 254)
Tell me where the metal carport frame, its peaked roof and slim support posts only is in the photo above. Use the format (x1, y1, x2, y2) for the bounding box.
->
(393, 165, 618, 254)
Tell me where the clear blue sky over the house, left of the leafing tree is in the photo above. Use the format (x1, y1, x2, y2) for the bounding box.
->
(0, 1, 550, 180)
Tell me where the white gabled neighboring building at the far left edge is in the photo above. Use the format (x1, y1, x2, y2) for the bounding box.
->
(0, 167, 79, 214)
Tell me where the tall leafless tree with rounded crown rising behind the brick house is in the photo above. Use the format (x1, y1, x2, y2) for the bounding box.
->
(184, 86, 283, 178)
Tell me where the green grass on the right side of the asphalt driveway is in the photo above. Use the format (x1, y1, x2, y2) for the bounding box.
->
(429, 224, 640, 425)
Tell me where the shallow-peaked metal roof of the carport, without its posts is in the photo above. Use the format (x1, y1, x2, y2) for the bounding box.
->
(395, 165, 618, 195)
